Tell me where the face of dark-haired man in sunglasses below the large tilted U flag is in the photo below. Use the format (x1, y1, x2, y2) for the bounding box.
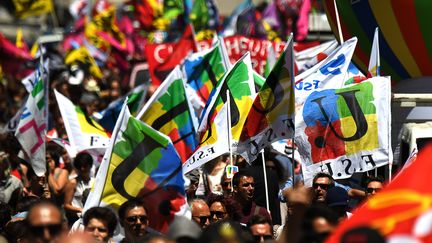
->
(123, 206, 149, 238)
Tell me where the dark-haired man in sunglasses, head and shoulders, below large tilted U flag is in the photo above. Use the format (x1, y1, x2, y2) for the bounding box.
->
(118, 198, 158, 243)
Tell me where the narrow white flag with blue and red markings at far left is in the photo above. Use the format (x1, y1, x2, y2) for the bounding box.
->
(15, 61, 49, 176)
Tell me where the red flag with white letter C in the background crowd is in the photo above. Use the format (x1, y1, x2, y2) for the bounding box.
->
(145, 24, 198, 85)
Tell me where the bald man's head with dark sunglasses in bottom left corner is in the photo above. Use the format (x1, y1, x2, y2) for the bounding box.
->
(27, 205, 63, 242)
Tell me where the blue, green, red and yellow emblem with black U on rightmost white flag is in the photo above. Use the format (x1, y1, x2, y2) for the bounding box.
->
(303, 82, 378, 163)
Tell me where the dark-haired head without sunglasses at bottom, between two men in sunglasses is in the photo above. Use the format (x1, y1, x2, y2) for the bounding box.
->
(83, 207, 117, 243)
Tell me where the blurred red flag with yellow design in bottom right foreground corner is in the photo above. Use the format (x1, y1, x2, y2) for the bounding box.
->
(326, 145, 432, 243)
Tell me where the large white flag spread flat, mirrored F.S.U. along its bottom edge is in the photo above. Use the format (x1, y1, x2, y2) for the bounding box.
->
(295, 77, 392, 182)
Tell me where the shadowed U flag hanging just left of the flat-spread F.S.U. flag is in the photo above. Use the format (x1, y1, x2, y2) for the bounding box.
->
(235, 36, 295, 161)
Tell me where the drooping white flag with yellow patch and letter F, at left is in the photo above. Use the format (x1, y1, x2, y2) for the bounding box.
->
(54, 90, 111, 156)
